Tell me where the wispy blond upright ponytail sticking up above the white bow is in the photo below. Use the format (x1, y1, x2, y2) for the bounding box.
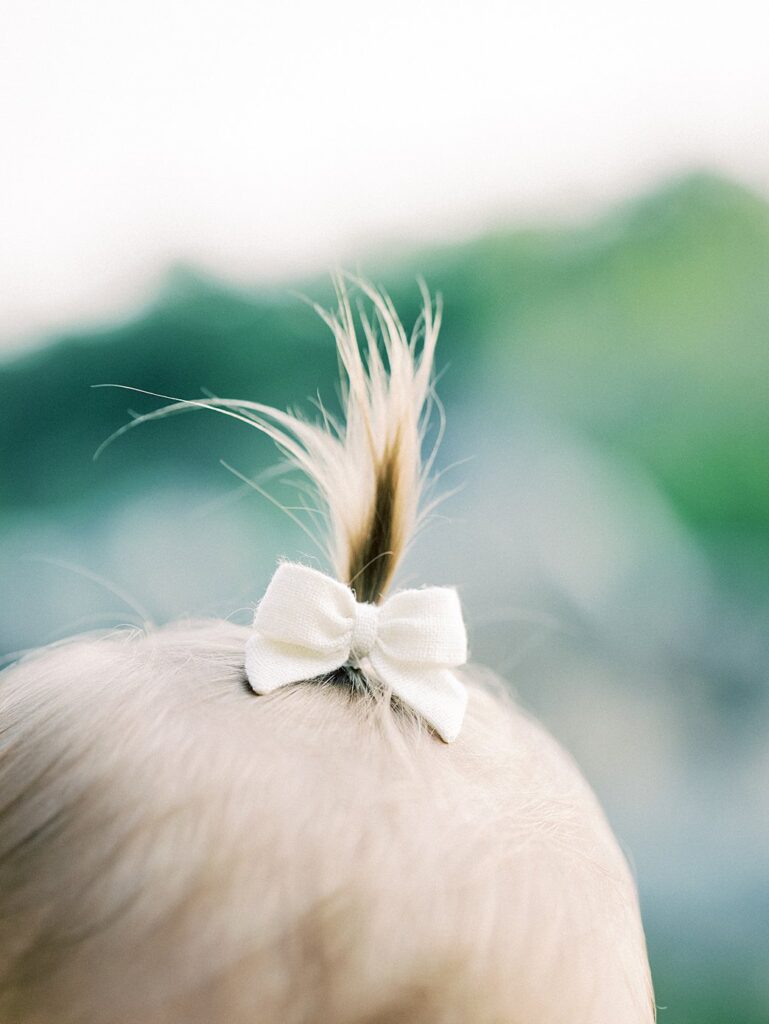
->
(97, 275, 440, 604)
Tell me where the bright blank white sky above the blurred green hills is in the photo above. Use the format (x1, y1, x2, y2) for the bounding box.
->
(0, 0, 769, 346)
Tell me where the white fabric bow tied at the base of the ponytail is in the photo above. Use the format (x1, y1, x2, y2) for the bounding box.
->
(246, 562, 467, 743)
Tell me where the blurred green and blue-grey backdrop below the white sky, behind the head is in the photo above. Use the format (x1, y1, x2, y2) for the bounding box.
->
(0, 173, 769, 1024)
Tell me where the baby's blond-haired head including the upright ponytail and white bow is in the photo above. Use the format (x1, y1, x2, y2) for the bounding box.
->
(0, 282, 654, 1024)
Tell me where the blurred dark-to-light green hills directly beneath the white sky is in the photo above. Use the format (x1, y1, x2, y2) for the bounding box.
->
(0, 175, 769, 552)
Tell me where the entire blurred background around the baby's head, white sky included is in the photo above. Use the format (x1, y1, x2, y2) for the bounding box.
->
(0, 0, 769, 1024)
